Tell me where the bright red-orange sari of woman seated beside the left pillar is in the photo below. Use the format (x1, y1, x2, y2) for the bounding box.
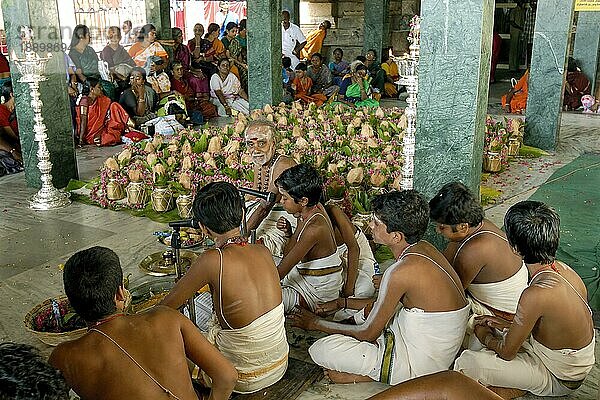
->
(77, 96, 129, 146)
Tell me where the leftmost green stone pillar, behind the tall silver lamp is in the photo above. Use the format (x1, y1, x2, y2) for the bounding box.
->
(1, 0, 78, 188)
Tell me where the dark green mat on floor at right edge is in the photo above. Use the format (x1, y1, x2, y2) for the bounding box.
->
(530, 154, 600, 310)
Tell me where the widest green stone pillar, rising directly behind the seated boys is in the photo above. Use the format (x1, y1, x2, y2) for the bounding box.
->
(414, 0, 494, 197)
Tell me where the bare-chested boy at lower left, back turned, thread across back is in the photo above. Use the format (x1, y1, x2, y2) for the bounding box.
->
(49, 247, 237, 400)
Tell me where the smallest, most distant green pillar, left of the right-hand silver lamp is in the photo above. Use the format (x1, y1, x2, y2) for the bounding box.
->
(363, 0, 390, 54)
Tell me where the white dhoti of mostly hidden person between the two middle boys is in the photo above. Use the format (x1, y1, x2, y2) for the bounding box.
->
(333, 229, 377, 321)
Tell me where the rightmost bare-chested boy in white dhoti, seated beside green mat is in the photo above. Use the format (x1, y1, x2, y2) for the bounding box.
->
(454, 201, 595, 398)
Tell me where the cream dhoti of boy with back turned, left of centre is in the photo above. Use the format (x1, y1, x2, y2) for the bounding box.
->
(204, 303, 289, 393)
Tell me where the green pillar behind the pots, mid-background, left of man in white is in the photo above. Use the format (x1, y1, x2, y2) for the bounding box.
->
(248, 0, 283, 109)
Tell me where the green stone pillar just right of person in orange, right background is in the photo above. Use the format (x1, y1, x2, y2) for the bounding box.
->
(524, 0, 575, 150)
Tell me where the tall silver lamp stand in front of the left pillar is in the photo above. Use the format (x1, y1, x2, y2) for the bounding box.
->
(12, 30, 71, 210)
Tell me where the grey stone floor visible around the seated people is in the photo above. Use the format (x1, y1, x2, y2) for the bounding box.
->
(0, 86, 600, 400)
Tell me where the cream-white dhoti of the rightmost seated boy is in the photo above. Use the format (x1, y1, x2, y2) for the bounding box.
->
(454, 335, 596, 396)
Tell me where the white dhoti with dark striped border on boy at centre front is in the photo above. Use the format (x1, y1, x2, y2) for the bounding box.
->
(308, 305, 469, 385)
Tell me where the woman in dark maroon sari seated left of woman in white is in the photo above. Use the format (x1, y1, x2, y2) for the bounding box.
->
(171, 61, 218, 122)
